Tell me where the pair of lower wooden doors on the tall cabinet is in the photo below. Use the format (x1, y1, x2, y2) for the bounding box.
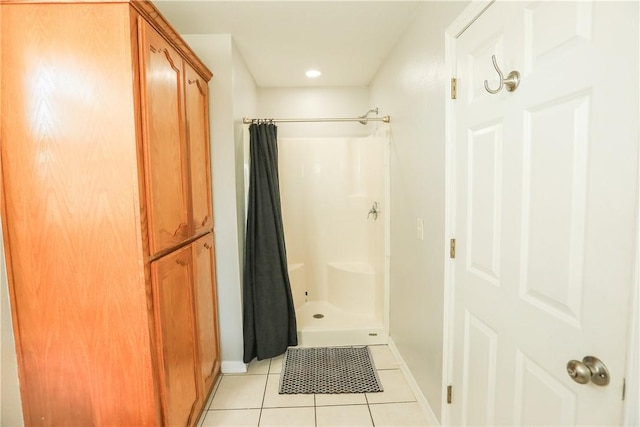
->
(151, 233, 220, 426)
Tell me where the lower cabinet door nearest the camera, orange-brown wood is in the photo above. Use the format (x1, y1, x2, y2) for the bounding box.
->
(151, 246, 200, 426)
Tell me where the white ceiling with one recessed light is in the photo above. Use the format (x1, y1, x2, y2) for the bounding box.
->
(149, 0, 421, 87)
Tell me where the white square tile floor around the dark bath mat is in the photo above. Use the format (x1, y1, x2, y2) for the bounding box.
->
(199, 345, 428, 427)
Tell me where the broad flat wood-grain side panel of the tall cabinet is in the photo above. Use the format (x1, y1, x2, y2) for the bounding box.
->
(1, 4, 157, 426)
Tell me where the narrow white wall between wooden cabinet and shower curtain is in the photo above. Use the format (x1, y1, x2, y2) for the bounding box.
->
(183, 34, 256, 372)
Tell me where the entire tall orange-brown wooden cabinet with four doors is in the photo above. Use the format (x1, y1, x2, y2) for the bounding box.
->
(0, 0, 220, 426)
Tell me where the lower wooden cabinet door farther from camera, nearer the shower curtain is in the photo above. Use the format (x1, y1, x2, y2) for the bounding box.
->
(193, 233, 220, 395)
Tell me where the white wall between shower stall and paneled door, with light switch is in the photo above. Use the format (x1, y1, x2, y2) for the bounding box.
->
(370, 1, 468, 419)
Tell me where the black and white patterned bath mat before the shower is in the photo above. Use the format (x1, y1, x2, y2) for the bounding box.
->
(279, 347, 382, 394)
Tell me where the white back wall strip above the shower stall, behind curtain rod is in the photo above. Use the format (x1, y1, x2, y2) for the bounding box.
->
(258, 87, 372, 138)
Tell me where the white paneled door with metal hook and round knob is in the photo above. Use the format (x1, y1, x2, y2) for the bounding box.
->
(450, 1, 639, 425)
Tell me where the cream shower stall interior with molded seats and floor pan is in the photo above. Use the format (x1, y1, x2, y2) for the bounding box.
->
(278, 131, 388, 346)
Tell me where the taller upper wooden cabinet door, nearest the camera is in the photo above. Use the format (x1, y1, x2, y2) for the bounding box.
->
(139, 19, 190, 254)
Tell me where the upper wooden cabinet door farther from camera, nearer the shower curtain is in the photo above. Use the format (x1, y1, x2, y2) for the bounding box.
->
(185, 63, 213, 234)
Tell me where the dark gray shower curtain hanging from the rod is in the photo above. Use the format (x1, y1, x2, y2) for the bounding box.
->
(243, 123, 298, 363)
